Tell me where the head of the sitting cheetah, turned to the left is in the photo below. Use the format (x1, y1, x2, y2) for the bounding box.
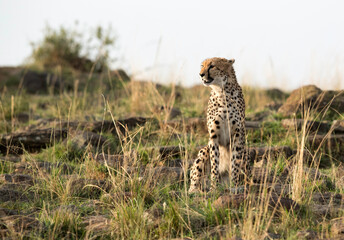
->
(199, 58, 235, 88)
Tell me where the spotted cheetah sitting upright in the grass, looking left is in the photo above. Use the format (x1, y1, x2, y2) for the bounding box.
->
(189, 58, 251, 192)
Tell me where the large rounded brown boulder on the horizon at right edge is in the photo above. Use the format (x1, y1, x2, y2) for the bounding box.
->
(278, 85, 344, 116)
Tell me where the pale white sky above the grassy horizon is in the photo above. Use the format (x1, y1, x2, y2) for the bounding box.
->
(0, 0, 344, 90)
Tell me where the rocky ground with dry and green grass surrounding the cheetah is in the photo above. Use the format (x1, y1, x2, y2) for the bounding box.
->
(0, 68, 344, 239)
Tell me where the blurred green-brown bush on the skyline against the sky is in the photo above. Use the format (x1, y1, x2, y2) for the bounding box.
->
(31, 25, 115, 72)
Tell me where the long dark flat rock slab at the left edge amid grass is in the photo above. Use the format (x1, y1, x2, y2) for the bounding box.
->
(0, 128, 67, 154)
